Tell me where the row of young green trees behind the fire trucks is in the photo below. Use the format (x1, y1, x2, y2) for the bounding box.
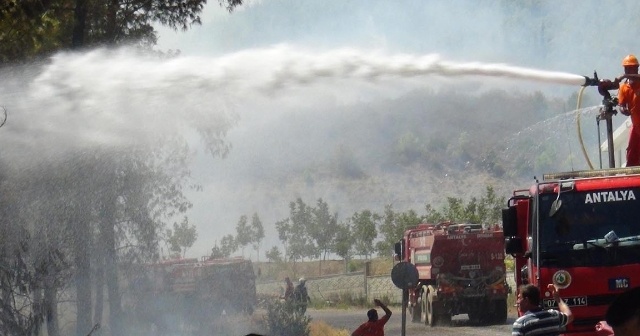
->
(212, 186, 505, 263)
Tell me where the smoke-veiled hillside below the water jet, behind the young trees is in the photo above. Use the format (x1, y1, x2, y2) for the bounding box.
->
(193, 84, 618, 260)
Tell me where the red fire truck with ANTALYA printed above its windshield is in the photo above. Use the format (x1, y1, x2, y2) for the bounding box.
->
(502, 167, 640, 335)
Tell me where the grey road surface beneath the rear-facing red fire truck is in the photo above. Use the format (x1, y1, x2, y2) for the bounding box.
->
(307, 308, 515, 336)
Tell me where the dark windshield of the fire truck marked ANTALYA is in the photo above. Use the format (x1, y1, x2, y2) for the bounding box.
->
(538, 188, 640, 267)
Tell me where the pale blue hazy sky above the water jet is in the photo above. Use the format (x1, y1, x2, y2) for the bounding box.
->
(158, 0, 637, 75)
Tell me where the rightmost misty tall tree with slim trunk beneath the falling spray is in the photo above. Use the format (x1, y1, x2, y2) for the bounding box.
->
(97, 144, 191, 336)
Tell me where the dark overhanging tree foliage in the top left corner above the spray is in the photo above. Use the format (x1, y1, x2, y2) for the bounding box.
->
(0, 0, 242, 62)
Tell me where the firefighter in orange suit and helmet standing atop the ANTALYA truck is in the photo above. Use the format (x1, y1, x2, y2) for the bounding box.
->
(598, 55, 640, 167)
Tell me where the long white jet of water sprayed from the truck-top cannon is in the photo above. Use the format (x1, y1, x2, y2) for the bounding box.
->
(0, 45, 585, 158)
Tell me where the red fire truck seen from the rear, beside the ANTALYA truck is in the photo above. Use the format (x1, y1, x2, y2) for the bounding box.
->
(395, 223, 509, 326)
